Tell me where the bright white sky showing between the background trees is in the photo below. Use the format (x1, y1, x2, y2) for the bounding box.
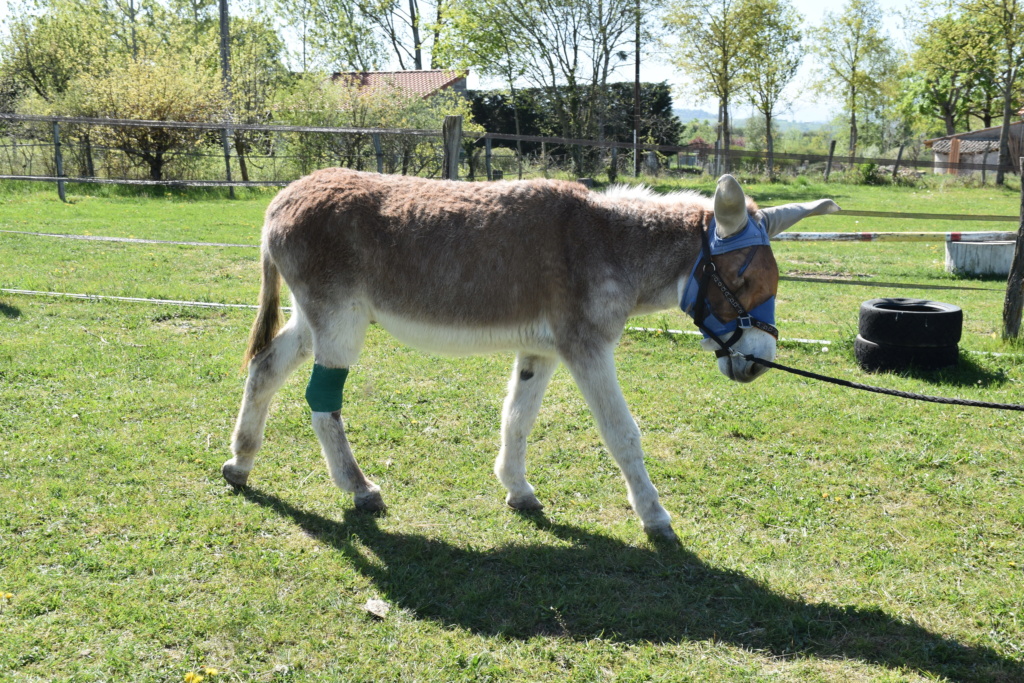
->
(0, 0, 918, 122)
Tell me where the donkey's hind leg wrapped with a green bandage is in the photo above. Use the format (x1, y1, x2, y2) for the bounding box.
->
(306, 305, 385, 512)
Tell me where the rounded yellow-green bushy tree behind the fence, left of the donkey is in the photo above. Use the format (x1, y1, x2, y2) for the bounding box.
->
(62, 59, 225, 180)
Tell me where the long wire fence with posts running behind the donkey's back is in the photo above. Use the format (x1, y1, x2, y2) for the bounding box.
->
(0, 114, 1017, 191)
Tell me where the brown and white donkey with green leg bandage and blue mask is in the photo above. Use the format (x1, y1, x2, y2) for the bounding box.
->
(221, 169, 839, 539)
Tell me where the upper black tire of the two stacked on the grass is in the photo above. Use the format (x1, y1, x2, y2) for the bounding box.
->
(858, 298, 964, 348)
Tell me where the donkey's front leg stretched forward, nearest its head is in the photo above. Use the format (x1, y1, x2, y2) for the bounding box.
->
(563, 344, 677, 540)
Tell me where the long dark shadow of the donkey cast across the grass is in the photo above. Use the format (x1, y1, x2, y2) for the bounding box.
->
(243, 488, 1024, 682)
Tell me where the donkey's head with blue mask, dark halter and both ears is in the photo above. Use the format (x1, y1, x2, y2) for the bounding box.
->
(680, 175, 839, 382)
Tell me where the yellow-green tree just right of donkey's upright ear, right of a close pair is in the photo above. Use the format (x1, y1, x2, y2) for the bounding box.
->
(741, 0, 804, 177)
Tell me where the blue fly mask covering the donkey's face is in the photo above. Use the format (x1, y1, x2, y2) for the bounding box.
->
(679, 216, 778, 356)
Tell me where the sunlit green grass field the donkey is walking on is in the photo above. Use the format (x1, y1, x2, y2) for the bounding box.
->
(0, 182, 1024, 682)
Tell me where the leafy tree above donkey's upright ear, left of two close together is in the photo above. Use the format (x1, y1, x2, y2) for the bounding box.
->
(665, 0, 754, 170)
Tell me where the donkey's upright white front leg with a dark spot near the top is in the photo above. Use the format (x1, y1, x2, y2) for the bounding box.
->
(495, 353, 558, 510)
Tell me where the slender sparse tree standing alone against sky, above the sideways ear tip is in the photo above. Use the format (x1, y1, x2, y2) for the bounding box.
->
(814, 0, 895, 160)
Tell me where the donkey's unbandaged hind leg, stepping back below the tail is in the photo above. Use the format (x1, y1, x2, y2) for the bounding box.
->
(226, 310, 312, 486)
